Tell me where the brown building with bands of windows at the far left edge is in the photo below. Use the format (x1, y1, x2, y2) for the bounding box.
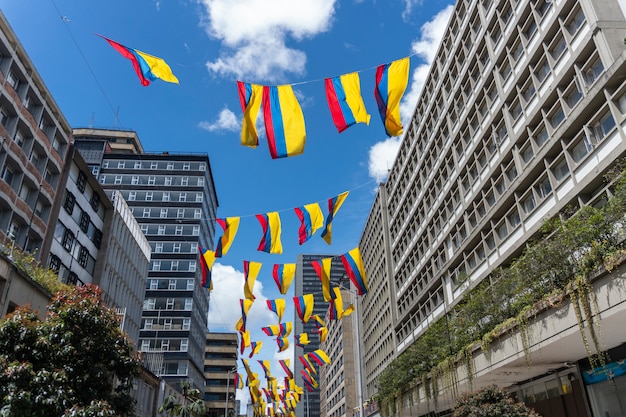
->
(0, 12, 71, 252)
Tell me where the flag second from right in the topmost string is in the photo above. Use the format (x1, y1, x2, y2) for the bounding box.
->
(324, 72, 370, 133)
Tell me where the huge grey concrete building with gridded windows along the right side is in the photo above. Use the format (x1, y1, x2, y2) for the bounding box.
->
(360, 0, 626, 416)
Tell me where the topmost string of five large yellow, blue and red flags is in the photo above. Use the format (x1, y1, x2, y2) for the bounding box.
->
(98, 35, 410, 159)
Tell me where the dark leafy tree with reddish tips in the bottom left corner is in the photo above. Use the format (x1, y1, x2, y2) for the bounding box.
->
(0, 285, 141, 417)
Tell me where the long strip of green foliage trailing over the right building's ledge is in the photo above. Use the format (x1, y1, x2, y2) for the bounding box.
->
(378, 164, 626, 402)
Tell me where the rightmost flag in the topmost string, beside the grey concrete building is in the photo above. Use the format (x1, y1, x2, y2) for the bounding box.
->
(374, 57, 410, 137)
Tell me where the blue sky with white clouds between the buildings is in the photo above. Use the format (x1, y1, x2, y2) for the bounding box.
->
(0, 0, 452, 410)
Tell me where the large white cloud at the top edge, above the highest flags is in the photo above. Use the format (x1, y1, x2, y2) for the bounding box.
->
(199, 0, 336, 82)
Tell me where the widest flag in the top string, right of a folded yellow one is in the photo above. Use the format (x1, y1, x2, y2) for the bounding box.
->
(263, 84, 306, 159)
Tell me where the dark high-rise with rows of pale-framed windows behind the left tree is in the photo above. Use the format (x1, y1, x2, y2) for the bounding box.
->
(74, 129, 217, 390)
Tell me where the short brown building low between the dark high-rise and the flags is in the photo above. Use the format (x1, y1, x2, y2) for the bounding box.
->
(204, 332, 239, 417)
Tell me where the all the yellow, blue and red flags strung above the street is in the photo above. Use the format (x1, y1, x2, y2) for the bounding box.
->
(98, 35, 376, 417)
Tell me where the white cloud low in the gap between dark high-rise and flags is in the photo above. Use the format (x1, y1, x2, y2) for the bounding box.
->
(208, 263, 276, 332)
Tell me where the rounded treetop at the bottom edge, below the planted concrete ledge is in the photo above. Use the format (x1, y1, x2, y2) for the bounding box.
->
(452, 385, 538, 417)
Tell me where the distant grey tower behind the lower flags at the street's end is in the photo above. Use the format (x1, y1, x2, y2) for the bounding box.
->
(293, 254, 346, 417)
